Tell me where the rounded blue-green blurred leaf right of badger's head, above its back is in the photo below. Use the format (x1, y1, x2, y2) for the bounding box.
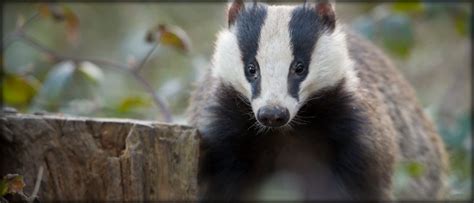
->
(379, 14, 415, 57)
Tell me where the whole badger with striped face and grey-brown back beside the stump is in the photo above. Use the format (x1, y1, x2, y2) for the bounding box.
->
(189, 0, 448, 201)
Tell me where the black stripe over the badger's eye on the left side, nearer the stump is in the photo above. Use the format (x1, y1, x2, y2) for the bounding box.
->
(235, 4, 267, 98)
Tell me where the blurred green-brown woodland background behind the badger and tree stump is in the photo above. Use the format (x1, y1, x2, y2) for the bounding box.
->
(1, 1, 472, 199)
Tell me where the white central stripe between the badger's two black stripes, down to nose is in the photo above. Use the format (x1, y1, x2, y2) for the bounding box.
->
(252, 6, 297, 118)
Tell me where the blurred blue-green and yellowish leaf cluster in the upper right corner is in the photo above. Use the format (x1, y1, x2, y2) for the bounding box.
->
(352, 0, 472, 58)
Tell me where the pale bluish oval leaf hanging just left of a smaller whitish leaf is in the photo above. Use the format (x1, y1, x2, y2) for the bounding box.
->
(34, 61, 75, 103)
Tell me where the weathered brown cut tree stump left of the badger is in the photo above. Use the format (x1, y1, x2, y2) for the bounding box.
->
(0, 113, 199, 201)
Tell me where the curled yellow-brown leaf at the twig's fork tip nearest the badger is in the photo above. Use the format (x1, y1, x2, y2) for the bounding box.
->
(146, 24, 190, 52)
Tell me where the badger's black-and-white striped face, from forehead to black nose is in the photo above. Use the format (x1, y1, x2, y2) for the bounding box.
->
(212, 1, 355, 127)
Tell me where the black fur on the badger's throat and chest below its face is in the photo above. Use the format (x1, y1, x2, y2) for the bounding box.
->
(199, 79, 386, 200)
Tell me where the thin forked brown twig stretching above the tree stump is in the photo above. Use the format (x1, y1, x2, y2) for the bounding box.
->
(6, 19, 173, 122)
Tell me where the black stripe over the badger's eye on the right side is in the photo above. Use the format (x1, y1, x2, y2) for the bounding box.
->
(288, 6, 329, 100)
